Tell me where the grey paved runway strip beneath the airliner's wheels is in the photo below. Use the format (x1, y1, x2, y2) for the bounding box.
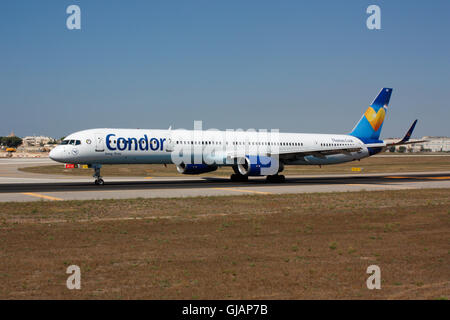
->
(0, 158, 450, 202)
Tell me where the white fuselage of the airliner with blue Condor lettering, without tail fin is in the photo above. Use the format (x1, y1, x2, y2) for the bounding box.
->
(50, 129, 369, 166)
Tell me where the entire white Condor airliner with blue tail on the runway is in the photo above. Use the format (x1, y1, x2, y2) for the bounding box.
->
(49, 88, 424, 185)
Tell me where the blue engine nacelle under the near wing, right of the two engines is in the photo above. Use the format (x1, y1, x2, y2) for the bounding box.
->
(237, 156, 284, 176)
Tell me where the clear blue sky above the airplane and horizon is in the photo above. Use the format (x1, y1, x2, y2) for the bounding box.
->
(0, 0, 450, 138)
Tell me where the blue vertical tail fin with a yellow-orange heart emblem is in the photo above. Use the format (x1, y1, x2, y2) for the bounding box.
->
(350, 88, 392, 142)
